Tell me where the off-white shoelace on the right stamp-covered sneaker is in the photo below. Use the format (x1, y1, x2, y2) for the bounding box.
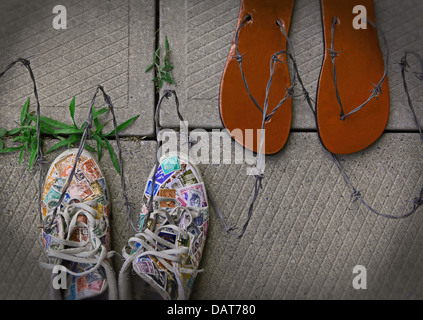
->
(122, 197, 203, 274)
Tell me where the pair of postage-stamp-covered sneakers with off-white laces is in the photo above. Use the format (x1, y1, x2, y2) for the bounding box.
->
(41, 149, 209, 300)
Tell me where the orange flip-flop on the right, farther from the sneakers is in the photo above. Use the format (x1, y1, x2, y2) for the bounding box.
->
(316, 0, 389, 154)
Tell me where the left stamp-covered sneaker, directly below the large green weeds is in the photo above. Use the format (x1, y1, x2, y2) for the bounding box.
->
(41, 149, 117, 300)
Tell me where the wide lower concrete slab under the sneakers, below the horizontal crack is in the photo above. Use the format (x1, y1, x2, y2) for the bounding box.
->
(0, 133, 423, 299)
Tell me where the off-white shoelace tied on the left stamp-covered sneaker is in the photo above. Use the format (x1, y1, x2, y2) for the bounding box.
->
(40, 198, 116, 277)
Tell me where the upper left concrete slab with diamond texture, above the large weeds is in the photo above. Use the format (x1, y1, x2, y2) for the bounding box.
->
(0, 0, 155, 136)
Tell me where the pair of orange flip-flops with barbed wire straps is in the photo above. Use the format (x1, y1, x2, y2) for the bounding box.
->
(219, 0, 389, 154)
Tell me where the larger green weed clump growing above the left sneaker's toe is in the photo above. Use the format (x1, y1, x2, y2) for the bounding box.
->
(0, 97, 139, 174)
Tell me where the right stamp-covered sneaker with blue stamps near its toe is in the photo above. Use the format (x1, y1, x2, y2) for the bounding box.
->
(119, 155, 209, 300)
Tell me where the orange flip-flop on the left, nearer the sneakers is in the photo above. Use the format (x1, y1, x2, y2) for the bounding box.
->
(219, 0, 294, 154)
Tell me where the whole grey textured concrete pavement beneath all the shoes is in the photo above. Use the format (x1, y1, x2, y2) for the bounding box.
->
(0, 0, 423, 299)
